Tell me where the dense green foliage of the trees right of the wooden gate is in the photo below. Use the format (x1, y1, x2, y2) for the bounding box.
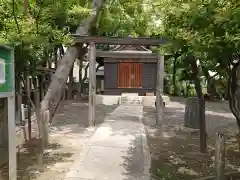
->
(150, 0, 240, 99)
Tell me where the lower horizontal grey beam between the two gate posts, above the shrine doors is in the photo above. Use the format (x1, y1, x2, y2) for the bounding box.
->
(96, 51, 158, 60)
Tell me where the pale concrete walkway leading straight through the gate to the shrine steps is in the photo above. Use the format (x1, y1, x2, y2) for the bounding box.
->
(65, 105, 151, 180)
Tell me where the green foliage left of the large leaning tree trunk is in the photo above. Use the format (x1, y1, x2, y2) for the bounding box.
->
(0, 0, 90, 74)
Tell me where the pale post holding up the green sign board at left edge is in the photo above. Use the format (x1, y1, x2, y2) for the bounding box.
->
(8, 95, 17, 180)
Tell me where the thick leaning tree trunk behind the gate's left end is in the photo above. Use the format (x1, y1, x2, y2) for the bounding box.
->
(41, 0, 104, 141)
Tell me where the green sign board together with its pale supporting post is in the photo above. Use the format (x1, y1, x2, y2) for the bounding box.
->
(0, 45, 17, 180)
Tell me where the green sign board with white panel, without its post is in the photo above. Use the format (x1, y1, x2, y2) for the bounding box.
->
(0, 45, 15, 93)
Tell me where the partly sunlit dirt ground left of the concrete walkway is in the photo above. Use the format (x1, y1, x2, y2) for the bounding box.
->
(0, 101, 116, 180)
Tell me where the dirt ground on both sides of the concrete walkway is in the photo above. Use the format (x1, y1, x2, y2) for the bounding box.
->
(0, 98, 240, 180)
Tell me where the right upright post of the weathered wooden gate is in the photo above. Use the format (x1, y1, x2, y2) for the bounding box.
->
(156, 55, 164, 125)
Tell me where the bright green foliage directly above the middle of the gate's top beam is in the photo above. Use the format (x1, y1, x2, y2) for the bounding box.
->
(96, 0, 151, 36)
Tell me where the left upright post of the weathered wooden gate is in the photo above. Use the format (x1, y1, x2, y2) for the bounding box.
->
(88, 42, 96, 126)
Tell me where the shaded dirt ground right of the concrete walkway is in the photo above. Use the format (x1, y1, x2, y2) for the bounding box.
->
(143, 98, 240, 180)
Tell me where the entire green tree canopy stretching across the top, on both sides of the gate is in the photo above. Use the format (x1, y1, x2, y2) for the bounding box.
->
(0, 0, 240, 121)
